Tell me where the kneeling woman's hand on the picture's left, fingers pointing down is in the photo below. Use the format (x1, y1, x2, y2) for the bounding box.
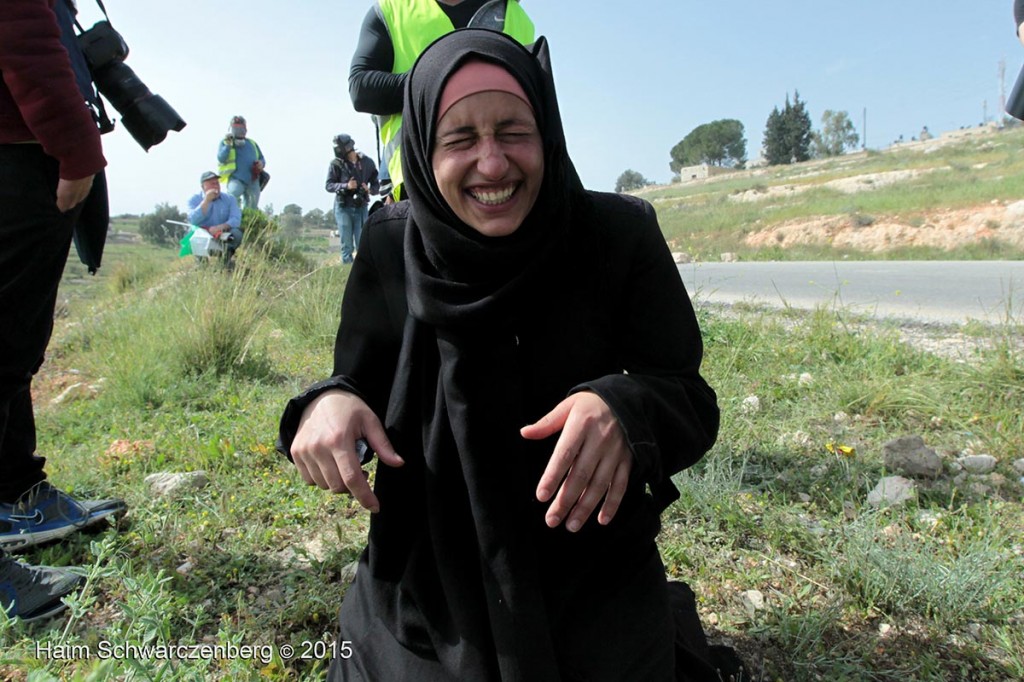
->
(291, 390, 404, 512)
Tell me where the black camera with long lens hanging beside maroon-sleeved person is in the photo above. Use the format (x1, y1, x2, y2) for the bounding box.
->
(78, 22, 185, 151)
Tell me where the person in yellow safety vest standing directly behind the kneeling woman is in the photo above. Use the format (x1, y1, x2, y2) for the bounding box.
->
(348, 0, 535, 200)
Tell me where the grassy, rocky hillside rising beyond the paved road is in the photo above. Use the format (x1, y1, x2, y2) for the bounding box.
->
(637, 122, 1024, 260)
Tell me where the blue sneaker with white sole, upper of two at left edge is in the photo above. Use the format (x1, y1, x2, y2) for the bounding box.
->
(0, 480, 127, 550)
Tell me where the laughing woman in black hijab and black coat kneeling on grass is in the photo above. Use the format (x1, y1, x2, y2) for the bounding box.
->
(281, 30, 718, 682)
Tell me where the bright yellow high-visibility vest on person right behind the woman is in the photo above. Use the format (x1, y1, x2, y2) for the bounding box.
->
(378, 0, 534, 199)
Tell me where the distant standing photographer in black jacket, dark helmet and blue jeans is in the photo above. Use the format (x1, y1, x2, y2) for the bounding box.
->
(326, 133, 380, 263)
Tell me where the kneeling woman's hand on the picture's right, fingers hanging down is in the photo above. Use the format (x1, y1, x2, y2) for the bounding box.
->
(519, 391, 633, 532)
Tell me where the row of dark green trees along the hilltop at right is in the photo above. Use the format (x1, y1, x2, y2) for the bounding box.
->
(615, 92, 860, 191)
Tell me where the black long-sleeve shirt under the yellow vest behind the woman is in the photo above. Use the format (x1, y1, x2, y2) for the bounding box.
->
(348, 0, 487, 116)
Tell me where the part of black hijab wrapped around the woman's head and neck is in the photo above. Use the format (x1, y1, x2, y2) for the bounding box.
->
(401, 29, 583, 327)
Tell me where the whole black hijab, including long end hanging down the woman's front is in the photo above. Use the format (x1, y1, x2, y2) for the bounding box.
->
(371, 29, 585, 682)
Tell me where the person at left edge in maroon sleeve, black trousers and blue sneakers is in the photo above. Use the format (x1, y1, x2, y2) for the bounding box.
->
(0, 0, 126, 623)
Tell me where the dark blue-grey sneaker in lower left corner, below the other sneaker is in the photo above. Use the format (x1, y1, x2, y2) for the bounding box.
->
(0, 554, 85, 623)
